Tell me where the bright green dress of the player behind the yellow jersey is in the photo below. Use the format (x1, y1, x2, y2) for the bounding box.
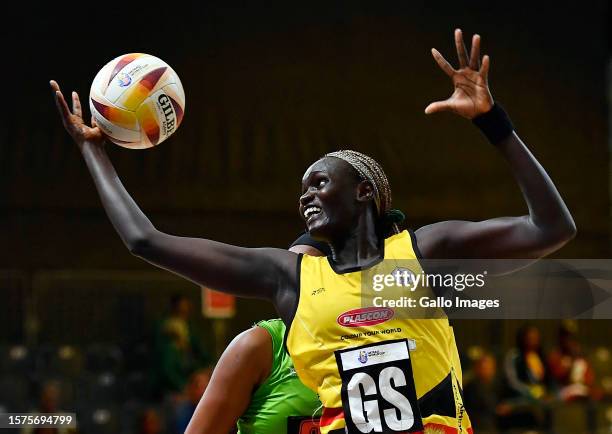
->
(238, 319, 321, 434)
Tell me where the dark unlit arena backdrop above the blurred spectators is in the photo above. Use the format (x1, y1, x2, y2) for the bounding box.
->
(0, 1, 612, 432)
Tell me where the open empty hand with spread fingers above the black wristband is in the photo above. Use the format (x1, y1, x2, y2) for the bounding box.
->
(425, 29, 493, 119)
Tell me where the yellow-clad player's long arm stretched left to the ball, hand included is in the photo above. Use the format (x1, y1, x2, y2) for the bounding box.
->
(51, 81, 297, 302)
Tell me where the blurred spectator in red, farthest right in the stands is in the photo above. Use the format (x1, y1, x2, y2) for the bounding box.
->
(548, 321, 600, 401)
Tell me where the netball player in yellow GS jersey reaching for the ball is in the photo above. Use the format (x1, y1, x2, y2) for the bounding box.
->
(52, 30, 576, 434)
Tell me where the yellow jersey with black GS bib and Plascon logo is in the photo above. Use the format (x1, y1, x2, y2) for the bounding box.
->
(286, 231, 472, 434)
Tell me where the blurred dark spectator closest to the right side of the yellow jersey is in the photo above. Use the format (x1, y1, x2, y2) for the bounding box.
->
(464, 353, 500, 434)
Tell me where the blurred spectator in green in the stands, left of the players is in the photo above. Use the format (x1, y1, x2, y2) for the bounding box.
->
(153, 295, 210, 397)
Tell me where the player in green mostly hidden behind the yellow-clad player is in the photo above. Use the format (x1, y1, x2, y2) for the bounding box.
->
(185, 234, 330, 434)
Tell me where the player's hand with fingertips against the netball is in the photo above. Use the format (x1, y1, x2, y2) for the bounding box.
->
(49, 80, 104, 148)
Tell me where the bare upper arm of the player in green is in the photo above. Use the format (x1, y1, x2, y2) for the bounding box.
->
(185, 327, 272, 434)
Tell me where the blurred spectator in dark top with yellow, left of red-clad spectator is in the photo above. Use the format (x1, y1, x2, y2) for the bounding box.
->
(497, 325, 550, 431)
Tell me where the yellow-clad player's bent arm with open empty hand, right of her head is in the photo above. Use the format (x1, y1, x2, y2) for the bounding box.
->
(416, 30, 576, 259)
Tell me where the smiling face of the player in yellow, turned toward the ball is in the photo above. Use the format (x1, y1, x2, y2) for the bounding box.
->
(299, 157, 359, 242)
